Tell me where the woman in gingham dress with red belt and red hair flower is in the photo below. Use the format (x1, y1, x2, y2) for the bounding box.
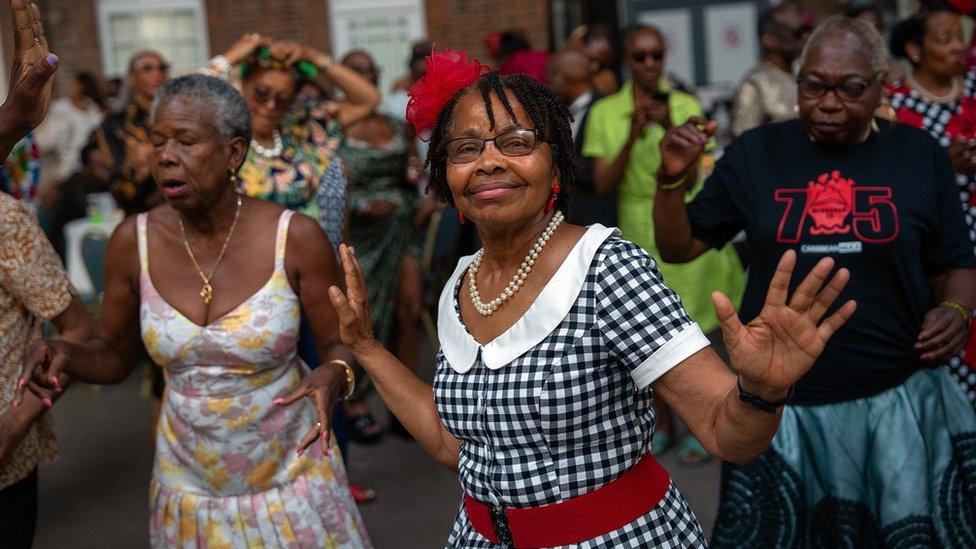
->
(330, 57, 854, 548)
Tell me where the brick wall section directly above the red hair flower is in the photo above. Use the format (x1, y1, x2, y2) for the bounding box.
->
(427, 0, 549, 63)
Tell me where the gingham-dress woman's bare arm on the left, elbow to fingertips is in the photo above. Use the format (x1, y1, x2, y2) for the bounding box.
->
(329, 244, 461, 471)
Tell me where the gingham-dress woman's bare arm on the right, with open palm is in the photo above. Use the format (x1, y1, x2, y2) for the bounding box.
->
(652, 250, 855, 463)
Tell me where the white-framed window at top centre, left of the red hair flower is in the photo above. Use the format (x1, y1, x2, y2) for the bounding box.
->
(329, 0, 427, 94)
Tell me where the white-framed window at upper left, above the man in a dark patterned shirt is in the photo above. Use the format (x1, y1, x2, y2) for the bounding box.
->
(98, 0, 210, 76)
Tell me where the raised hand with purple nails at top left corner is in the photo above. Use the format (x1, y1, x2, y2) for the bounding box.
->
(0, 0, 58, 135)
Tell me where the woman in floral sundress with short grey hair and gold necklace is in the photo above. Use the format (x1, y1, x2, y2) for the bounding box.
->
(19, 75, 369, 547)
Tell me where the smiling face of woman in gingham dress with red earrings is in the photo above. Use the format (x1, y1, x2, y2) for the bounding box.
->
(446, 91, 559, 227)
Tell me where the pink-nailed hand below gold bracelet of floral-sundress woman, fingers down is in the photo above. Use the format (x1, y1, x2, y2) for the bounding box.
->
(274, 364, 346, 456)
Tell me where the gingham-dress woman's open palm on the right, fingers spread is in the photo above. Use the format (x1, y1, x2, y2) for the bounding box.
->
(712, 250, 856, 401)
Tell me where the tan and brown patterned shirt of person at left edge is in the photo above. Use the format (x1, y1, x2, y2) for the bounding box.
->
(0, 193, 74, 489)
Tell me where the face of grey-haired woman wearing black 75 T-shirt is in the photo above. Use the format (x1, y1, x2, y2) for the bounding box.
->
(797, 32, 882, 146)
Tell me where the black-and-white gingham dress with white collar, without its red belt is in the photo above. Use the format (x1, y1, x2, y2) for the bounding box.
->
(434, 225, 708, 547)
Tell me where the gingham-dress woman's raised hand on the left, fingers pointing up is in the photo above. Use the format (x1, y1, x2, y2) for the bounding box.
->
(329, 244, 378, 354)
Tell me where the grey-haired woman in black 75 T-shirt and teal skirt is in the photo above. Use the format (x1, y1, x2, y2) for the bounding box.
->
(654, 17, 976, 547)
